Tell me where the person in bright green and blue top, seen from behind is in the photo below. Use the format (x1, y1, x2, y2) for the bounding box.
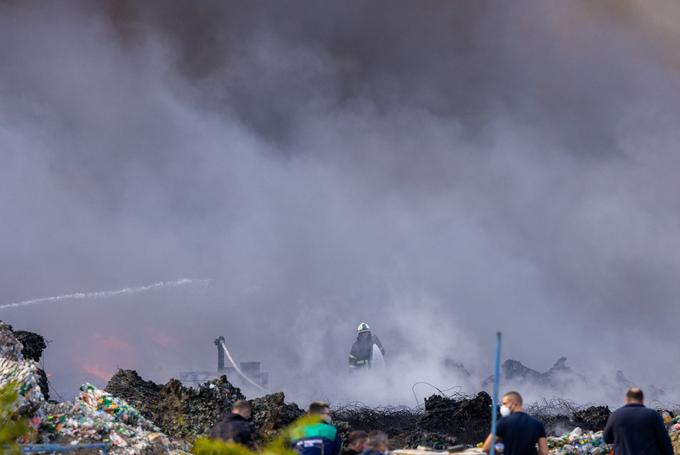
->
(291, 401, 342, 455)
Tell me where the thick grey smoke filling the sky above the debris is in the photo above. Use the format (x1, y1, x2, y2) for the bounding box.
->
(0, 0, 680, 404)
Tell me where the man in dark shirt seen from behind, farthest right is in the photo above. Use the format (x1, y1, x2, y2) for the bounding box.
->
(604, 387, 673, 455)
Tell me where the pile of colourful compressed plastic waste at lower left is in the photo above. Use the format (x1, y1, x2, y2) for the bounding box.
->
(0, 321, 185, 454)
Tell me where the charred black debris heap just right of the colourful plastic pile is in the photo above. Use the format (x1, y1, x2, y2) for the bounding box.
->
(105, 370, 304, 441)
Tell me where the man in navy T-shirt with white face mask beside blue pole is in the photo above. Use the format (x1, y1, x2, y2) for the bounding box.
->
(482, 392, 548, 455)
